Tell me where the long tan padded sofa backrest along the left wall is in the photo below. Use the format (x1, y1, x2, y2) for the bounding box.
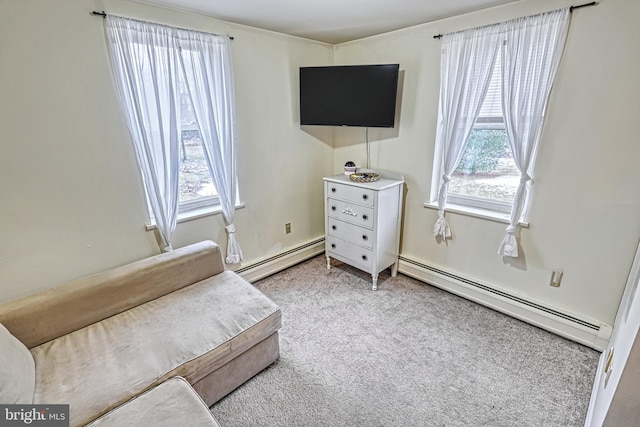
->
(0, 241, 225, 348)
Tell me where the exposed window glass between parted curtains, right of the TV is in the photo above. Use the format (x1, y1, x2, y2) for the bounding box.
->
(448, 52, 520, 213)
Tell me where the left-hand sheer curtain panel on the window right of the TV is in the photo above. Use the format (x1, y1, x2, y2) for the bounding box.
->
(433, 26, 499, 240)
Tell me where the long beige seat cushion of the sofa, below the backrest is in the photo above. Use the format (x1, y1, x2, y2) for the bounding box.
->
(31, 271, 281, 425)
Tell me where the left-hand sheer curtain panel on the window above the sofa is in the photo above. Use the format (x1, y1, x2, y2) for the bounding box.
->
(106, 16, 180, 251)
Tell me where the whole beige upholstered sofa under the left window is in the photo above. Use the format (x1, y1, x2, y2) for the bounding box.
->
(0, 241, 281, 426)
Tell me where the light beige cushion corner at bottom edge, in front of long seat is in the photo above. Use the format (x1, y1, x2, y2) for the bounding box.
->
(89, 377, 220, 427)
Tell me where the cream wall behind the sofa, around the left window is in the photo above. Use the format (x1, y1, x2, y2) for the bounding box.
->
(0, 0, 333, 301)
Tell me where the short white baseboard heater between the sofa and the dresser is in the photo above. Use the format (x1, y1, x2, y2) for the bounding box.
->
(235, 236, 324, 282)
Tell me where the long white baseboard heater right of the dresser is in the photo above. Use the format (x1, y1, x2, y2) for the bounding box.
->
(398, 256, 612, 351)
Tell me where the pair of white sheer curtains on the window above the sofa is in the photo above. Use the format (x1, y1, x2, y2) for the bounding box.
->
(106, 15, 243, 263)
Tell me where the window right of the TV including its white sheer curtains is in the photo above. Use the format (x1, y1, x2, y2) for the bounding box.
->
(429, 8, 570, 257)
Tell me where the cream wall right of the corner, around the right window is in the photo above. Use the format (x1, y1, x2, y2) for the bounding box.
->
(334, 0, 640, 325)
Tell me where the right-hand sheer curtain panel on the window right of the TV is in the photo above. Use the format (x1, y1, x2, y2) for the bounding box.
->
(498, 8, 570, 257)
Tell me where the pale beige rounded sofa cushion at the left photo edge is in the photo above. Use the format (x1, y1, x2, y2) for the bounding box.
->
(0, 324, 36, 404)
